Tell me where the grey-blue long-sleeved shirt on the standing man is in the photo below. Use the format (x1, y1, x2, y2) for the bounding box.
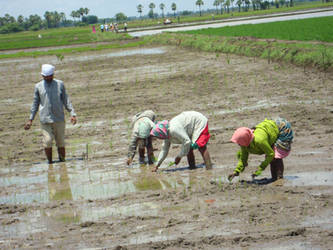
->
(30, 79, 76, 123)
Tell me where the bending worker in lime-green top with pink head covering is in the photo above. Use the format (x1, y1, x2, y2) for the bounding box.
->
(228, 118, 294, 181)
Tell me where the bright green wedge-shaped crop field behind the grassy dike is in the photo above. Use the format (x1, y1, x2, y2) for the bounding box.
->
(182, 16, 333, 42)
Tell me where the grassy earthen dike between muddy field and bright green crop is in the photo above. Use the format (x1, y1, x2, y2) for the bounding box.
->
(144, 33, 333, 72)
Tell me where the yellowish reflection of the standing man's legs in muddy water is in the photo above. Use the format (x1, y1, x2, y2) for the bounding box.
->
(48, 163, 73, 201)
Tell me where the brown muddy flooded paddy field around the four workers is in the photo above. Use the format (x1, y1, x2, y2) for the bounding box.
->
(0, 47, 333, 249)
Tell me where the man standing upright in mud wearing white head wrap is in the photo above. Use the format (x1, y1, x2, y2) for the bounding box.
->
(24, 64, 76, 164)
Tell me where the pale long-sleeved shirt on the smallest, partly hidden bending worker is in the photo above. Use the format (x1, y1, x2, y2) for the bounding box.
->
(127, 110, 156, 159)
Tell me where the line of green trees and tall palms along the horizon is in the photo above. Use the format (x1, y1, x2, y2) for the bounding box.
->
(0, 0, 333, 34)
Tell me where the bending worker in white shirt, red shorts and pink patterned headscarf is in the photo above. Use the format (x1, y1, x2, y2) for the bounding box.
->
(150, 111, 212, 171)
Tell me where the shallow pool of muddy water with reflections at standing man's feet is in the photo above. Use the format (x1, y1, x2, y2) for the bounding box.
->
(0, 159, 195, 204)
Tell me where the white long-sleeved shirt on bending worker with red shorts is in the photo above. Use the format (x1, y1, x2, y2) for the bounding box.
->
(157, 111, 208, 166)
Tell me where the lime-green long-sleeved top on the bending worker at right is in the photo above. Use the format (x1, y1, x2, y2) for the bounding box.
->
(234, 119, 279, 173)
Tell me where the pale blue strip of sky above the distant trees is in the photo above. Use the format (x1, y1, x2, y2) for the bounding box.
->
(0, 0, 215, 19)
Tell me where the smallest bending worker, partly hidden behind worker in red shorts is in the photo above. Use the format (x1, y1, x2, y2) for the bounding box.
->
(127, 110, 156, 165)
